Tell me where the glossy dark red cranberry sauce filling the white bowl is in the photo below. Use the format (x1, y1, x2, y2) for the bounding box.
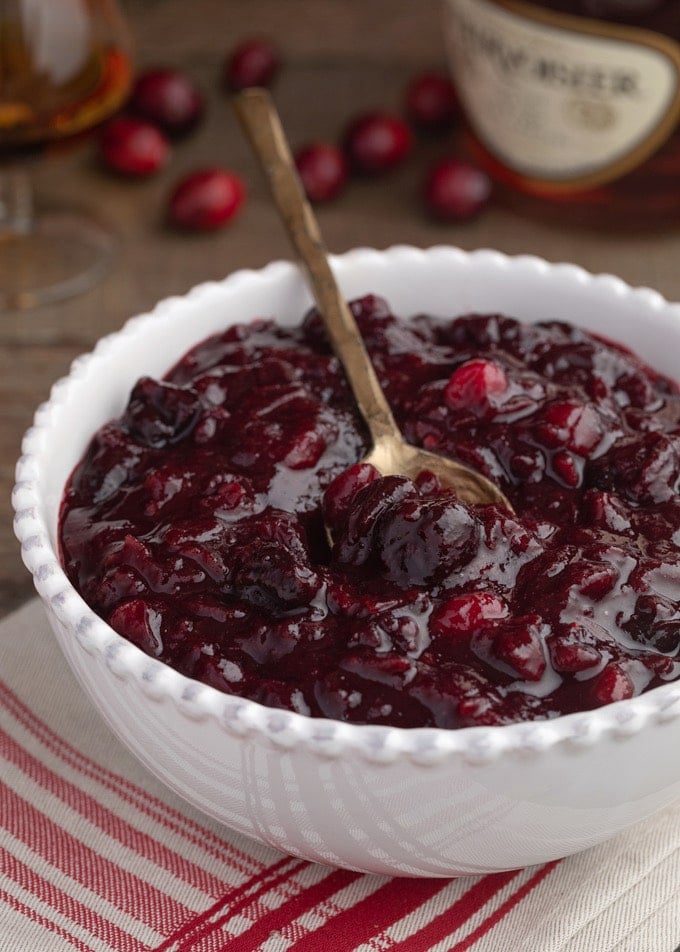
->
(61, 296, 680, 728)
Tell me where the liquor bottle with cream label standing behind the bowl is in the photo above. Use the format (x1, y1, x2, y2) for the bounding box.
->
(445, 0, 680, 228)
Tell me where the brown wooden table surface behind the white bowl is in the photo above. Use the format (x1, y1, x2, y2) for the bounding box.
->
(0, 0, 680, 613)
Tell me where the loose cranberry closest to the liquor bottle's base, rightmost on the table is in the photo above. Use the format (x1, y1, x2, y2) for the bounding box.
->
(423, 159, 492, 221)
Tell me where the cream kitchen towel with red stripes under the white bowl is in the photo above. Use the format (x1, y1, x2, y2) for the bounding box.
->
(0, 601, 680, 952)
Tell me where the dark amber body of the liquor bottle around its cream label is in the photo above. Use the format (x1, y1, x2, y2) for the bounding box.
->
(456, 0, 680, 231)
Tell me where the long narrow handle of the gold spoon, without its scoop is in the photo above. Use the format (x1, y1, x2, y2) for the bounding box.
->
(233, 87, 400, 444)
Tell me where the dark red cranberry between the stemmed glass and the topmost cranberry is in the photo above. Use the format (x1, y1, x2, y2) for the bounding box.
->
(129, 67, 204, 136)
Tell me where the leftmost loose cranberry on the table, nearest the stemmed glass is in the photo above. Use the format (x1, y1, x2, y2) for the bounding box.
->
(99, 116, 170, 178)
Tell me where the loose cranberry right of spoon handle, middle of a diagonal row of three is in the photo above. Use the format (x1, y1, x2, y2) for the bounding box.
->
(343, 112, 413, 175)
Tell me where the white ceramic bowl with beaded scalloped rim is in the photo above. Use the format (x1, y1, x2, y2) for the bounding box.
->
(13, 247, 680, 876)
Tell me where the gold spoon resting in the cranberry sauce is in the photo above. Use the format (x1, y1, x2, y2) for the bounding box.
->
(233, 87, 512, 512)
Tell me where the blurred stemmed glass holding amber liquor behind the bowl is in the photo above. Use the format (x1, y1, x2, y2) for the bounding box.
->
(0, 0, 132, 314)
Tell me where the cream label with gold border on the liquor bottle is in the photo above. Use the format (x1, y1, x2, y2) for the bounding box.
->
(445, 0, 680, 190)
